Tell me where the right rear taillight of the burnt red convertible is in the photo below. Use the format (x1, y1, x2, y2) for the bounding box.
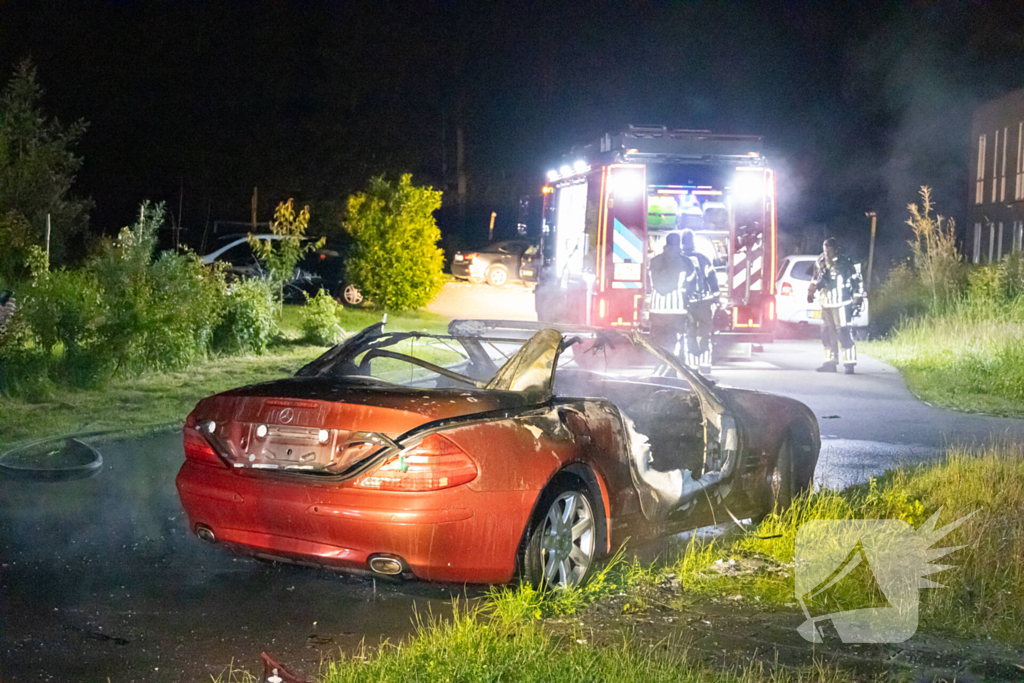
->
(354, 434, 477, 492)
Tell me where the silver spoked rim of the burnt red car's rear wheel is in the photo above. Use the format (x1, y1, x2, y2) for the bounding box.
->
(541, 490, 597, 588)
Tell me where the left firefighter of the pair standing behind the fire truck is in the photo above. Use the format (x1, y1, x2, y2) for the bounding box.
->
(647, 232, 693, 353)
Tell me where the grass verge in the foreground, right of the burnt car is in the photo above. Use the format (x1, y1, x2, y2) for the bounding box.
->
(217, 446, 1024, 683)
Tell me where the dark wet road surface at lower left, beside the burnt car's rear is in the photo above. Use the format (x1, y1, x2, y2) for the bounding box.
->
(0, 433, 464, 683)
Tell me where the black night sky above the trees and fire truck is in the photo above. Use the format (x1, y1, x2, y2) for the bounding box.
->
(0, 1, 1024, 264)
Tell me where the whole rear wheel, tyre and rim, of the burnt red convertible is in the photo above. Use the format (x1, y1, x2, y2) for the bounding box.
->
(519, 476, 600, 589)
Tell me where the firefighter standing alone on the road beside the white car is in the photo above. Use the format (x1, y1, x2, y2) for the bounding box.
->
(807, 238, 864, 375)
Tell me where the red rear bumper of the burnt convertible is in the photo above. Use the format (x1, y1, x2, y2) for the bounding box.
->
(177, 462, 539, 584)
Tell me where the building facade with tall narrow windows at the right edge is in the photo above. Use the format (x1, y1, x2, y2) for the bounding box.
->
(968, 90, 1024, 263)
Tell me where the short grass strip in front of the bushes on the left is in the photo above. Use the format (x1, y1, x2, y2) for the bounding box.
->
(0, 306, 449, 449)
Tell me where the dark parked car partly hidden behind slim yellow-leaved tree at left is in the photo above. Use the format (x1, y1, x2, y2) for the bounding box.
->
(203, 234, 362, 306)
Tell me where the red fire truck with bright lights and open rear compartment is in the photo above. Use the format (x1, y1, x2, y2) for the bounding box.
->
(536, 126, 776, 349)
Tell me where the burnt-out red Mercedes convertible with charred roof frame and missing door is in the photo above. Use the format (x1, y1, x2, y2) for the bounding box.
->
(177, 321, 820, 586)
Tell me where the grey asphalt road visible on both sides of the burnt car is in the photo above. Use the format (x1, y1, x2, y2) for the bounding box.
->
(0, 329, 1024, 683)
